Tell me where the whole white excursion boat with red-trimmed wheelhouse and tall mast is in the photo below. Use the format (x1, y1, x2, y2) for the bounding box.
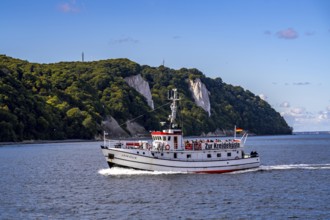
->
(101, 89, 260, 173)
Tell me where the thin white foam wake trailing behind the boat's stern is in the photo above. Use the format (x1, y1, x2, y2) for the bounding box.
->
(231, 164, 330, 174)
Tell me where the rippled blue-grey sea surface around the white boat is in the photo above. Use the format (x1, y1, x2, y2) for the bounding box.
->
(0, 135, 330, 219)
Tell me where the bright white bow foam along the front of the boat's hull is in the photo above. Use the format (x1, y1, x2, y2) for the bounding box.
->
(98, 167, 185, 176)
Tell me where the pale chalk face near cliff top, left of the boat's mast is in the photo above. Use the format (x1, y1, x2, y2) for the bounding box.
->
(125, 74, 154, 109)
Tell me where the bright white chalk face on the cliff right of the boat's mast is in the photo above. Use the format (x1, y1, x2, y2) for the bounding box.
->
(189, 78, 211, 116)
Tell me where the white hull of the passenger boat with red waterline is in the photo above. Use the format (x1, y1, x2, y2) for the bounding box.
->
(102, 148, 260, 173)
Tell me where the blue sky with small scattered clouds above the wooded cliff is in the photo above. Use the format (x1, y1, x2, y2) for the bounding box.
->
(0, 0, 330, 131)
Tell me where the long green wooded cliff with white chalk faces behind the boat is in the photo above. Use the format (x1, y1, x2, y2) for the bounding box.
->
(0, 55, 292, 141)
